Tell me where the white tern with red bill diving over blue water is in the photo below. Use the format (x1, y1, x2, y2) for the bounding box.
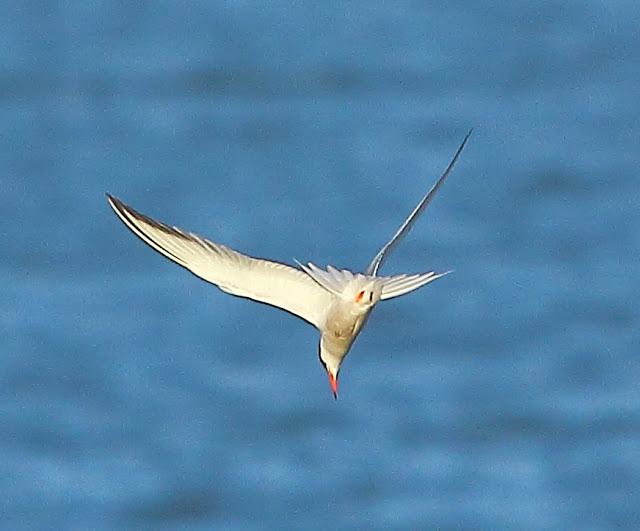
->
(107, 131, 471, 398)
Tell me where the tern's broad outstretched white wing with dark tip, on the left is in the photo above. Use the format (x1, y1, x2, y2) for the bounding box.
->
(107, 194, 333, 328)
